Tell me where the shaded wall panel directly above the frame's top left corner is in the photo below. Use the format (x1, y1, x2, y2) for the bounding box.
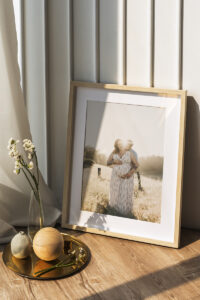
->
(72, 0, 97, 81)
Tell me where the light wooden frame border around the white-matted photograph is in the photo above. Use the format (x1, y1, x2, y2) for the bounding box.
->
(62, 81, 187, 248)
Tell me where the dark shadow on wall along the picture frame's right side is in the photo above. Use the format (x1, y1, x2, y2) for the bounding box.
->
(182, 97, 200, 228)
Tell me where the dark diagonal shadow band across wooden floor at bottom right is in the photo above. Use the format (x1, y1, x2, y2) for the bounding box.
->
(81, 255, 200, 300)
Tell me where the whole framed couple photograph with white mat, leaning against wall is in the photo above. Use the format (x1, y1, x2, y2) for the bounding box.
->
(62, 82, 186, 247)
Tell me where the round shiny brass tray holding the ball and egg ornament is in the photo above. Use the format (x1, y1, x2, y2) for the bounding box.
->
(2, 233, 91, 280)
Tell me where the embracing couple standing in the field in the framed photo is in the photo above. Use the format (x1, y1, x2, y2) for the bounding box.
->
(107, 139, 139, 216)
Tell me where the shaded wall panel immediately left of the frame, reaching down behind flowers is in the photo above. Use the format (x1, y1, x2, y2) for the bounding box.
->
(47, 0, 71, 206)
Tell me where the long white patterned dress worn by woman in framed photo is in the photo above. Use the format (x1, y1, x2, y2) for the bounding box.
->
(109, 151, 134, 215)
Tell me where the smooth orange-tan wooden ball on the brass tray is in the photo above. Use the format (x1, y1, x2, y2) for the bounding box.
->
(33, 227, 64, 261)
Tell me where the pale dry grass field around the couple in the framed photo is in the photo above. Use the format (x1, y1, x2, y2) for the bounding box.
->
(82, 163, 162, 223)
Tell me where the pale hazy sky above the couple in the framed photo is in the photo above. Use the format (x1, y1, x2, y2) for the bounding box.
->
(85, 101, 165, 157)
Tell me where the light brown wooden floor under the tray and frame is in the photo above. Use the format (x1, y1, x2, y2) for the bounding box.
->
(0, 230, 200, 300)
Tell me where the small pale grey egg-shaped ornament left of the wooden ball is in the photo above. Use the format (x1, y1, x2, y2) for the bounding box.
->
(11, 231, 32, 259)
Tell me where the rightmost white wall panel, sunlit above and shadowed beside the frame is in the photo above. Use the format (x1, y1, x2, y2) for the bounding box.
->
(183, 0, 200, 228)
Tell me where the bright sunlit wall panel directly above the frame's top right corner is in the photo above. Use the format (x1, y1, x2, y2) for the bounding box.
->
(154, 0, 181, 89)
